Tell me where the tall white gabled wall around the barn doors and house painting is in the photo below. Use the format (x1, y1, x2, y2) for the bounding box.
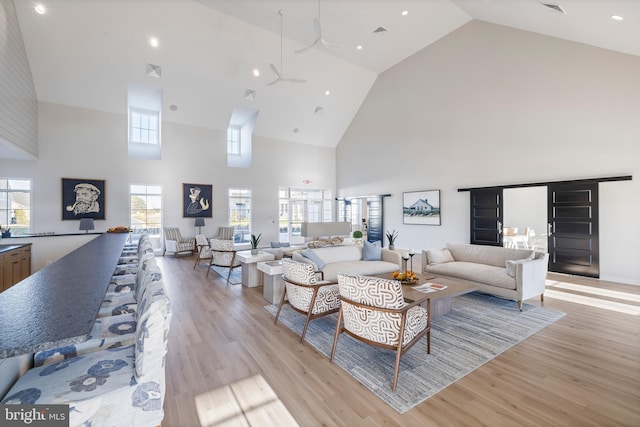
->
(337, 21, 640, 284)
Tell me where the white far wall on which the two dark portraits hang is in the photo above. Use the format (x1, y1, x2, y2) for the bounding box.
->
(0, 103, 336, 271)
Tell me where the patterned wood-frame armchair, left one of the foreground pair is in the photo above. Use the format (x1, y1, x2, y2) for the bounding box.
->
(273, 258, 340, 342)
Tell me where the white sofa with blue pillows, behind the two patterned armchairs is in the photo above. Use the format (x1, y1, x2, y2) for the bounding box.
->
(291, 245, 401, 282)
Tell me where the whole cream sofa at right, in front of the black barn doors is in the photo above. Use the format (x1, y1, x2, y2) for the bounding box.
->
(422, 243, 549, 310)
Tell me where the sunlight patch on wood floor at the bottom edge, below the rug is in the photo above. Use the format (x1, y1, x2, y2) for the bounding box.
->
(195, 375, 298, 427)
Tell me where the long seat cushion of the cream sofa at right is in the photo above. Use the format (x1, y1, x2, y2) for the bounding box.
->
(425, 261, 516, 289)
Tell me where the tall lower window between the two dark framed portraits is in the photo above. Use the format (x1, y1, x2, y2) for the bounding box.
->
(129, 184, 162, 250)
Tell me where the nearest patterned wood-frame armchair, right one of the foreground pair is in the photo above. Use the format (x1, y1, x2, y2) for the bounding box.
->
(331, 274, 431, 391)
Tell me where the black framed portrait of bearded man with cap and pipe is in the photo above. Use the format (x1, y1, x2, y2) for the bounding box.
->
(62, 178, 105, 220)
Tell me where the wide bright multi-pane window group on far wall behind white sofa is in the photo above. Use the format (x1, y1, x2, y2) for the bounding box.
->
(278, 188, 333, 243)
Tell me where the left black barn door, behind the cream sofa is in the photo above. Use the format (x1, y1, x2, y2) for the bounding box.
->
(470, 188, 502, 246)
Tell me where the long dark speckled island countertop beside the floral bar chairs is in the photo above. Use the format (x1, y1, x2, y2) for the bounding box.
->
(0, 233, 129, 359)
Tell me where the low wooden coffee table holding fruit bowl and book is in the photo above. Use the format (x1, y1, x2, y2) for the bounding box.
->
(376, 273, 478, 319)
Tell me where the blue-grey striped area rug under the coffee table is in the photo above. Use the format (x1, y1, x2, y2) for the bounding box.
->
(264, 292, 565, 414)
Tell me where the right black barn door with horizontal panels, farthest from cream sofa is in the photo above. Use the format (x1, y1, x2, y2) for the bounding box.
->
(547, 183, 600, 277)
